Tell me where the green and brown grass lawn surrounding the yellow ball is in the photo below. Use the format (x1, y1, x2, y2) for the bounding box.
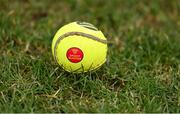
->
(0, 0, 180, 112)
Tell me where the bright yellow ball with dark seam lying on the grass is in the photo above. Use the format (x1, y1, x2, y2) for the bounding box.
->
(52, 22, 107, 73)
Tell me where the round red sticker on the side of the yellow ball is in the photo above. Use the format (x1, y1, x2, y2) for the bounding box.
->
(66, 47, 84, 63)
